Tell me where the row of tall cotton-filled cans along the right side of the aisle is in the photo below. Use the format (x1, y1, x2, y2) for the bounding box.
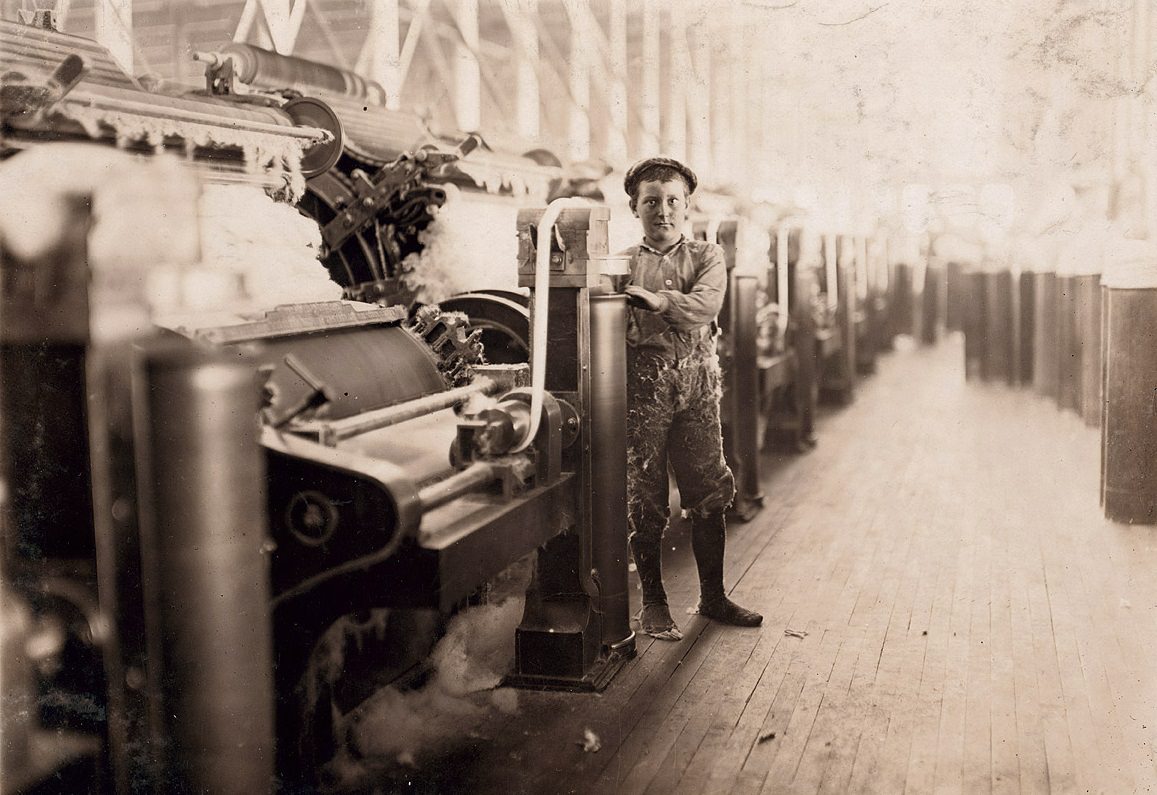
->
(948, 243, 1157, 524)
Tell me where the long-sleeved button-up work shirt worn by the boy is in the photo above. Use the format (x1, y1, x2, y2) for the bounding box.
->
(624, 237, 727, 361)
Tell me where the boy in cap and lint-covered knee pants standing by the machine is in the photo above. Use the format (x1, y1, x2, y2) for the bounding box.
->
(624, 157, 764, 640)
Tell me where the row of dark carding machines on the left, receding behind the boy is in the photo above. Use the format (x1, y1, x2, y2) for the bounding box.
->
(0, 15, 911, 793)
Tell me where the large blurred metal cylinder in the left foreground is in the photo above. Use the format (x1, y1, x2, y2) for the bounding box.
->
(133, 341, 274, 794)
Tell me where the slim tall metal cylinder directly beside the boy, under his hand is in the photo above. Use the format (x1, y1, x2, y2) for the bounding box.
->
(588, 295, 634, 649)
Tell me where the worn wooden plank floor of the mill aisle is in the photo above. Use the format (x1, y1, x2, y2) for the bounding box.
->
(342, 338, 1157, 794)
